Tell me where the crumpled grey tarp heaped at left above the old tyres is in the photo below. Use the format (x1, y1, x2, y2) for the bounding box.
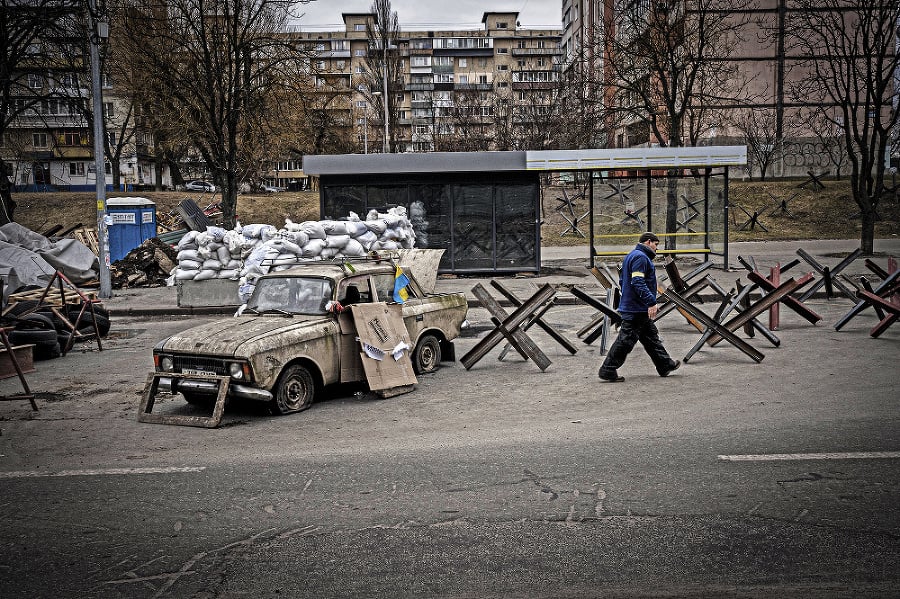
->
(0, 223, 100, 291)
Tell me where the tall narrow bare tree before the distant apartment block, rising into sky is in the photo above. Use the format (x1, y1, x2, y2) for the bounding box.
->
(364, 0, 403, 152)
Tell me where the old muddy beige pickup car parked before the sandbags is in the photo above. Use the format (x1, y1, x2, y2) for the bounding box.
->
(153, 260, 468, 414)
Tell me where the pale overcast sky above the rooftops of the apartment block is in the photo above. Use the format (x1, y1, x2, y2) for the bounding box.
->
(299, 0, 562, 30)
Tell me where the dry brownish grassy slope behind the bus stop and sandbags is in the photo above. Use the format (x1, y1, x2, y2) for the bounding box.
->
(14, 180, 900, 245)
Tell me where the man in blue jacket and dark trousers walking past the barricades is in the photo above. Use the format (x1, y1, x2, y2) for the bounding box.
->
(599, 232, 681, 383)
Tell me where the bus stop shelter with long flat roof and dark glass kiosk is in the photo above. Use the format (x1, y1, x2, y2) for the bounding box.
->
(303, 146, 747, 274)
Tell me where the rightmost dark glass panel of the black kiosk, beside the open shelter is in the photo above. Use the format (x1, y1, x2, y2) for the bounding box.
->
(496, 184, 537, 268)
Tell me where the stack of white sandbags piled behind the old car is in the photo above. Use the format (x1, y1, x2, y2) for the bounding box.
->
(173, 207, 416, 301)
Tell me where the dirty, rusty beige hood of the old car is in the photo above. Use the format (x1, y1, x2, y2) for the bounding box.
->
(163, 314, 337, 356)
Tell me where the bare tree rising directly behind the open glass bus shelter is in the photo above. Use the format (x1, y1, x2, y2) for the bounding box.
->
(598, 0, 749, 249)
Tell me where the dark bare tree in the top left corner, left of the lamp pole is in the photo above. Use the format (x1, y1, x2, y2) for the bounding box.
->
(0, 0, 83, 224)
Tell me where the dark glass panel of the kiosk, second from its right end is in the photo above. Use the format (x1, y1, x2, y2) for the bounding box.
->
(447, 184, 494, 269)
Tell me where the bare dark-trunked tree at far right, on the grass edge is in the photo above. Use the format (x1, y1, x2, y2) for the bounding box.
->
(791, 0, 900, 254)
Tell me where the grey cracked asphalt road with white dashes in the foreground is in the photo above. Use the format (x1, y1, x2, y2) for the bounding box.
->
(0, 300, 900, 598)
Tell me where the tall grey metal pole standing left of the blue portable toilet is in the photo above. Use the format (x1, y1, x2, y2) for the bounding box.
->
(88, 0, 112, 299)
